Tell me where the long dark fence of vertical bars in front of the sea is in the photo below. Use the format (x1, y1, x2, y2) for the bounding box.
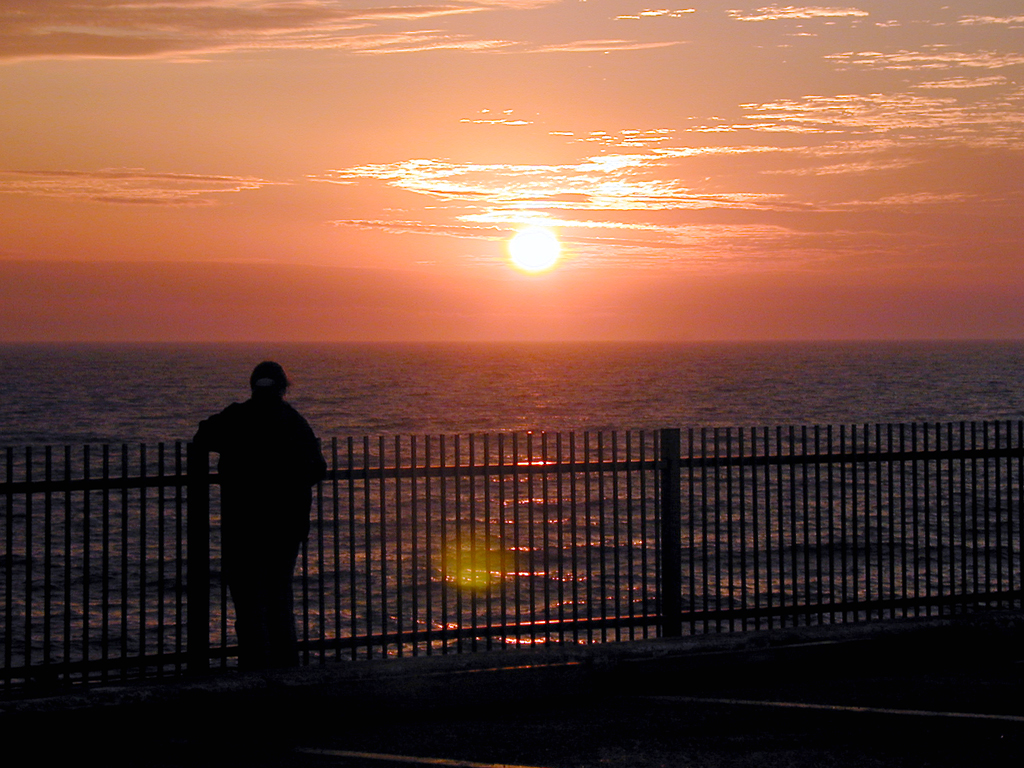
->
(0, 422, 1024, 689)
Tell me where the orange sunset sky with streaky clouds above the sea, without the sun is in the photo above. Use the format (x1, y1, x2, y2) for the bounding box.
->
(0, 0, 1024, 341)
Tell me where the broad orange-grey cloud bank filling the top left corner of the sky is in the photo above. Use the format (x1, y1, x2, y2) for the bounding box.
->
(0, 0, 556, 60)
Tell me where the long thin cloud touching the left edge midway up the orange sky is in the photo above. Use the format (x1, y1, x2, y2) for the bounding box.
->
(0, 168, 281, 206)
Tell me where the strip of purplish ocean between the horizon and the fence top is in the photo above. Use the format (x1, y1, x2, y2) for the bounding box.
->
(0, 342, 1024, 446)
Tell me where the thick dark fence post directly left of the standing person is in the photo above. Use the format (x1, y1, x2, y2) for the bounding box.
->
(185, 442, 210, 674)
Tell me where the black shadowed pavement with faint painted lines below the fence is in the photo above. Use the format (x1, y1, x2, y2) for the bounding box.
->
(8, 613, 1024, 768)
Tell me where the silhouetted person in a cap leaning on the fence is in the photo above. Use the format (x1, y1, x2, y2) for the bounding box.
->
(193, 361, 327, 670)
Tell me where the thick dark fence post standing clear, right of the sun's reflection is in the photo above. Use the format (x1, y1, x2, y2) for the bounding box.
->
(659, 429, 683, 637)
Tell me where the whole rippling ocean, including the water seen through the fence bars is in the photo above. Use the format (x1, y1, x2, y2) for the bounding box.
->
(0, 342, 1024, 667)
